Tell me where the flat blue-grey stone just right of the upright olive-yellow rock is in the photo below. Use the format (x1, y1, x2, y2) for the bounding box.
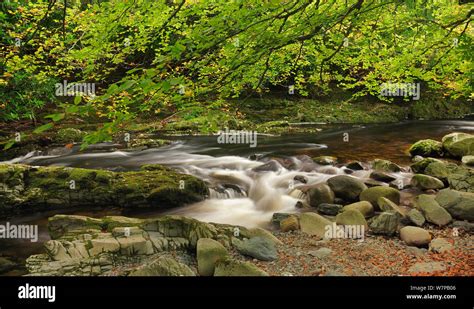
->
(234, 237, 278, 261)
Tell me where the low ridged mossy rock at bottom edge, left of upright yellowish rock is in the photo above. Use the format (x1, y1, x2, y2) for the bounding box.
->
(129, 257, 196, 277)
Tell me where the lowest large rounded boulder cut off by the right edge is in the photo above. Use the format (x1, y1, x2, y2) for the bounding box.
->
(435, 189, 474, 222)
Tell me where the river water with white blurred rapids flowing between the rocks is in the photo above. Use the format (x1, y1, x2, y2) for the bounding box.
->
(0, 120, 474, 272)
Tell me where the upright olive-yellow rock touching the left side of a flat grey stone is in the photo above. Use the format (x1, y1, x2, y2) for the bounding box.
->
(197, 238, 229, 276)
